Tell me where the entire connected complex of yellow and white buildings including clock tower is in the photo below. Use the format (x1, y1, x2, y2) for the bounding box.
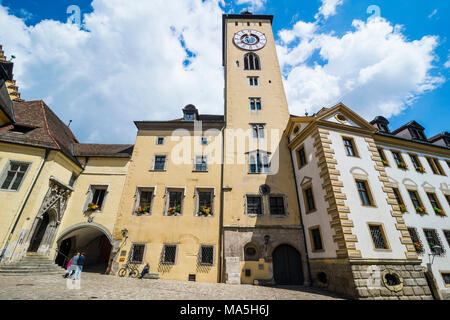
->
(0, 13, 450, 299)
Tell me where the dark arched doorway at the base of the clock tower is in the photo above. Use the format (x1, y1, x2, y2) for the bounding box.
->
(272, 245, 303, 285)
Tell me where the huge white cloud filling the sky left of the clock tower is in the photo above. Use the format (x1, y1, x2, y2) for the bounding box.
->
(0, 0, 223, 143)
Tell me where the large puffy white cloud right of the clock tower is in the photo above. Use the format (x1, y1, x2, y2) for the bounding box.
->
(277, 18, 444, 119)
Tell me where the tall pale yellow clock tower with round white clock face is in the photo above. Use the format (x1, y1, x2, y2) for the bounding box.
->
(222, 12, 309, 284)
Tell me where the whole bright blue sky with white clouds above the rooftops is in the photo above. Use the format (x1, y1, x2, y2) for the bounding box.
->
(0, 0, 450, 143)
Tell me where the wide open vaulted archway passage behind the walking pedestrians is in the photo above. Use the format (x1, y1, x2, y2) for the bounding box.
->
(55, 226, 112, 274)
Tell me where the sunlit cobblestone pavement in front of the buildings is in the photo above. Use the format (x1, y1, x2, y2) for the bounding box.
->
(0, 272, 339, 300)
